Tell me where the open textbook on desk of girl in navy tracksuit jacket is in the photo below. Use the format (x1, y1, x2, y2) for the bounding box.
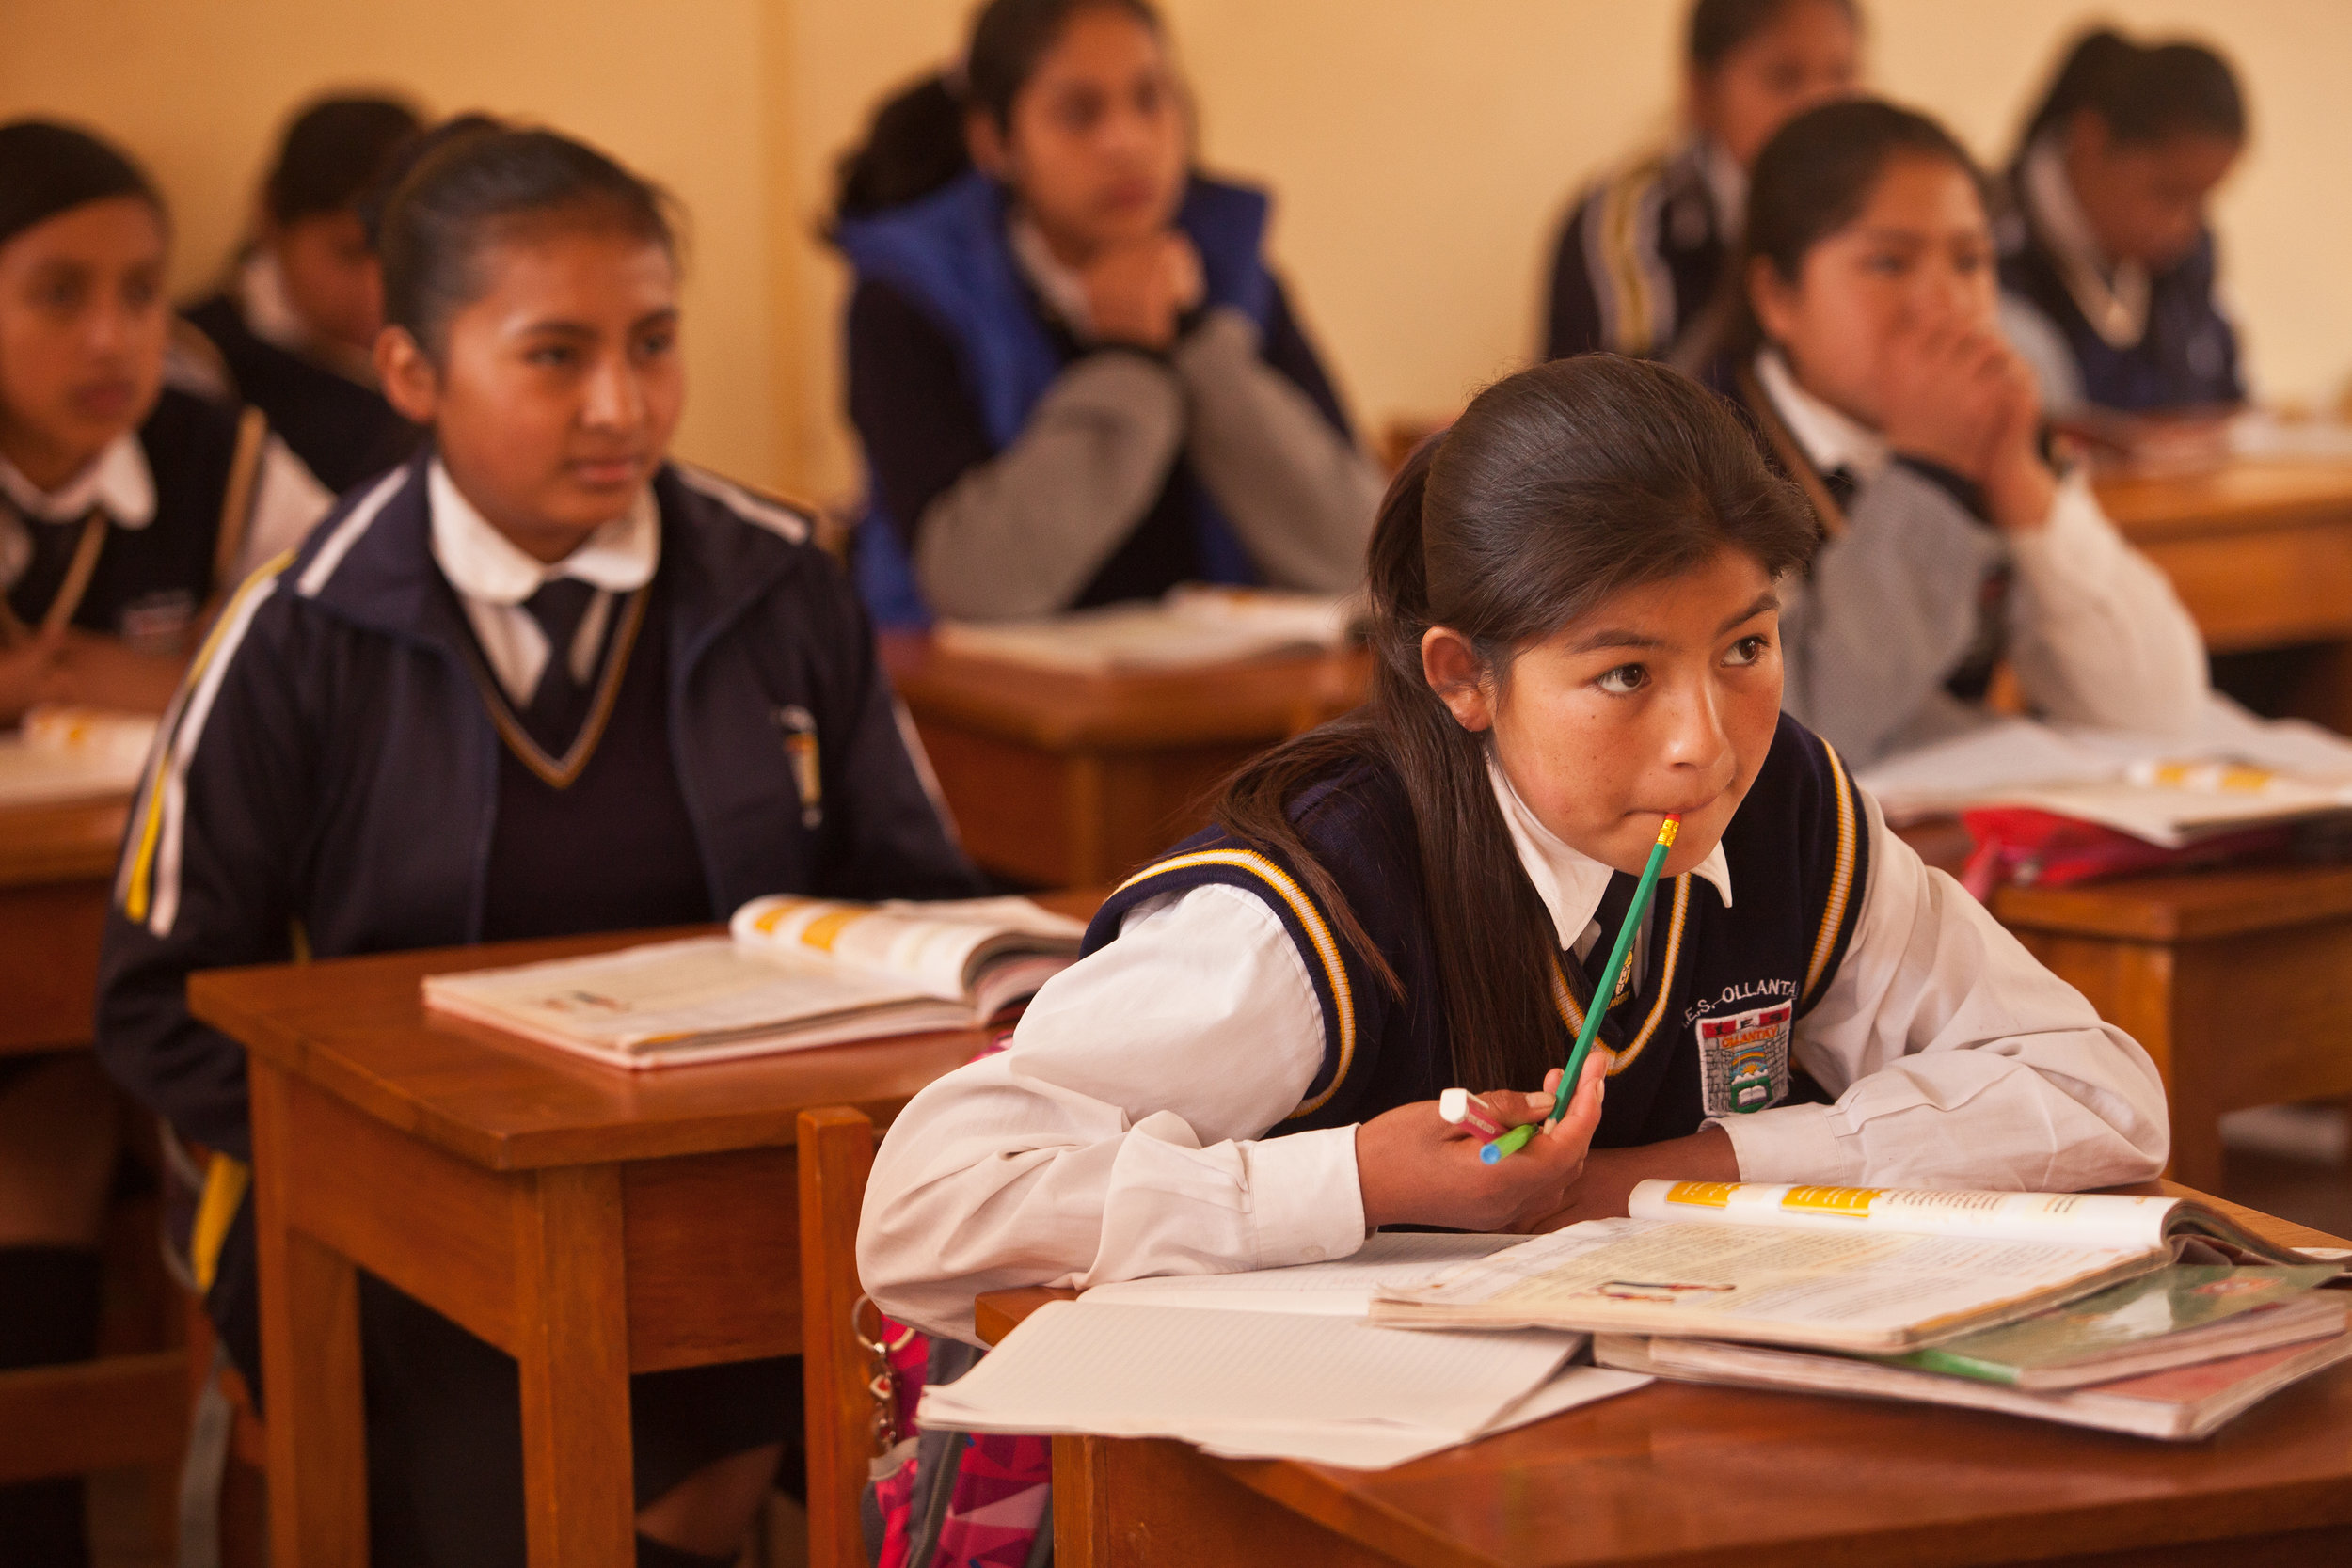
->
(423, 895, 1085, 1068)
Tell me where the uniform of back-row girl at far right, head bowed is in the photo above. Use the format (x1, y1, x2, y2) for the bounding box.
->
(1994, 136, 2247, 411)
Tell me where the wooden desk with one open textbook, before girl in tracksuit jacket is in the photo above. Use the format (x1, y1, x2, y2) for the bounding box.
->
(188, 894, 1099, 1568)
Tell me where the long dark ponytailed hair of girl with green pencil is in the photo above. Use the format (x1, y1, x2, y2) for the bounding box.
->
(1218, 355, 1814, 1088)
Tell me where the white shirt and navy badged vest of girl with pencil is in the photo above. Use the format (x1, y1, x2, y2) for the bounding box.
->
(859, 717, 2169, 1340)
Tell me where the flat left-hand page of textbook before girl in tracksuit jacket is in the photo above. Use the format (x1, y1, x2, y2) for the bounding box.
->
(423, 936, 946, 1053)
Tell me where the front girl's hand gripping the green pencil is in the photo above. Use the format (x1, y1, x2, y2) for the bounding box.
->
(1355, 1053, 1607, 1232)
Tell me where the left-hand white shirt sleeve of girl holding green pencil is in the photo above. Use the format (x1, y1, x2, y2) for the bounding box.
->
(859, 884, 1364, 1340)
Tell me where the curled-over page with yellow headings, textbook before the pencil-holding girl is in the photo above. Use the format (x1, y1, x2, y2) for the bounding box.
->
(1628, 1180, 2181, 1251)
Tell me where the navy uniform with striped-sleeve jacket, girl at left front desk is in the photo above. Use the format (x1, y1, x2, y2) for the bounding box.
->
(97, 451, 977, 1563)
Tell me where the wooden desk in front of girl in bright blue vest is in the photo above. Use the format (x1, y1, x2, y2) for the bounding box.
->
(882, 635, 1372, 886)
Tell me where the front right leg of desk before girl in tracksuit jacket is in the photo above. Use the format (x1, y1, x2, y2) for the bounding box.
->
(516, 1166, 638, 1568)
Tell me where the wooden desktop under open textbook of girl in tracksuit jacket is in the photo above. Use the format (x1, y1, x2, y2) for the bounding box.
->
(188, 894, 1101, 1171)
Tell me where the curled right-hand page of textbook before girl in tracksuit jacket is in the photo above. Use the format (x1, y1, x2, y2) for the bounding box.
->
(729, 894, 1087, 1002)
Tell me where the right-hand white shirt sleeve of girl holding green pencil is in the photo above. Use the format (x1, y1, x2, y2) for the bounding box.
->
(1720, 797, 2171, 1192)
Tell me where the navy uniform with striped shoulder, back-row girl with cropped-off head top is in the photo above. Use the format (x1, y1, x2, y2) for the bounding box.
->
(1543, 136, 1748, 364)
